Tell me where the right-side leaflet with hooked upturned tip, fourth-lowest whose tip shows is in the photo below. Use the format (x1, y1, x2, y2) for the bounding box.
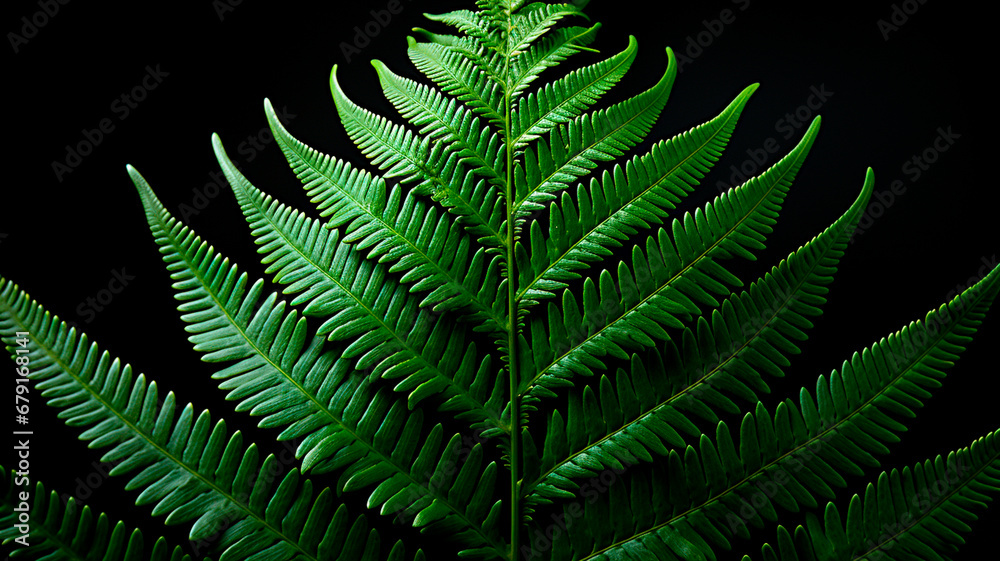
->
(513, 48, 677, 224)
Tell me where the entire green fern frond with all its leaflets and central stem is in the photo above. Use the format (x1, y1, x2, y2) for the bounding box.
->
(0, 0, 1000, 561)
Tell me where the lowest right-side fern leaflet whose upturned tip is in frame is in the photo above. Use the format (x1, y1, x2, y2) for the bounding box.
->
(525, 170, 874, 502)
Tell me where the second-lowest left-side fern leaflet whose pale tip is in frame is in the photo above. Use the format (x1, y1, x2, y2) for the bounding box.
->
(212, 136, 503, 428)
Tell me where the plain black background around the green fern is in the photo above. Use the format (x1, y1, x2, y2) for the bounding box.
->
(0, 0, 1000, 559)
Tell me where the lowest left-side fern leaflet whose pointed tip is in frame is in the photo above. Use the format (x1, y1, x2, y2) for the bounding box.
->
(129, 168, 503, 553)
